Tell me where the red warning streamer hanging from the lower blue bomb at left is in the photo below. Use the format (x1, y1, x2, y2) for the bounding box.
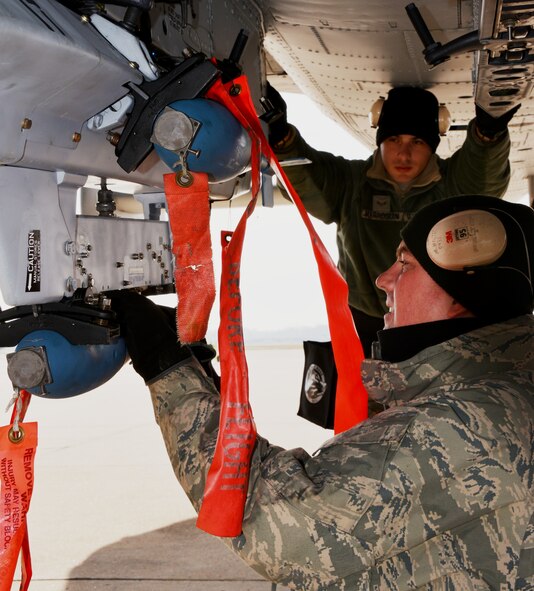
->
(0, 390, 37, 591)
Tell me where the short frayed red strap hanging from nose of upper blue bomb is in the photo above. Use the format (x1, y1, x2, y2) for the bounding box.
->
(163, 172, 219, 343)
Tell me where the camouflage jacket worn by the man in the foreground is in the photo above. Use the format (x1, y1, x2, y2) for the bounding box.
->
(150, 315, 534, 591)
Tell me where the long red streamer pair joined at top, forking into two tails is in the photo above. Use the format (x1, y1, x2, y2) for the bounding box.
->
(197, 76, 367, 536)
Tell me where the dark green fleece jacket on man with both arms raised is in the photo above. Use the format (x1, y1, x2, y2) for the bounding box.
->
(276, 121, 510, 317)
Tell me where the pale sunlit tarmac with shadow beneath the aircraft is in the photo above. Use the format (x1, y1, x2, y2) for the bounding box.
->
(5, 345, 332, 591)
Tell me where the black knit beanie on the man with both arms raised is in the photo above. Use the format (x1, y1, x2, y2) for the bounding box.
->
(376, 86, 440, 152)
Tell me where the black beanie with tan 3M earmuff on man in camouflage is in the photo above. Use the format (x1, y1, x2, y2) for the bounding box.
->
(401, 195, 534, 321)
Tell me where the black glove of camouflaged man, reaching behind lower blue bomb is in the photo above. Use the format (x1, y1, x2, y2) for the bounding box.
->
(108, 289, 192, 383)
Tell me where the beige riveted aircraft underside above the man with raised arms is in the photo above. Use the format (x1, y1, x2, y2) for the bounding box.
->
(262, 0, 534, 206)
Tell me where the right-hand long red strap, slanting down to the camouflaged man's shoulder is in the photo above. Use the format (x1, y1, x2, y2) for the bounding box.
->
(207, 76, 367, 433)
